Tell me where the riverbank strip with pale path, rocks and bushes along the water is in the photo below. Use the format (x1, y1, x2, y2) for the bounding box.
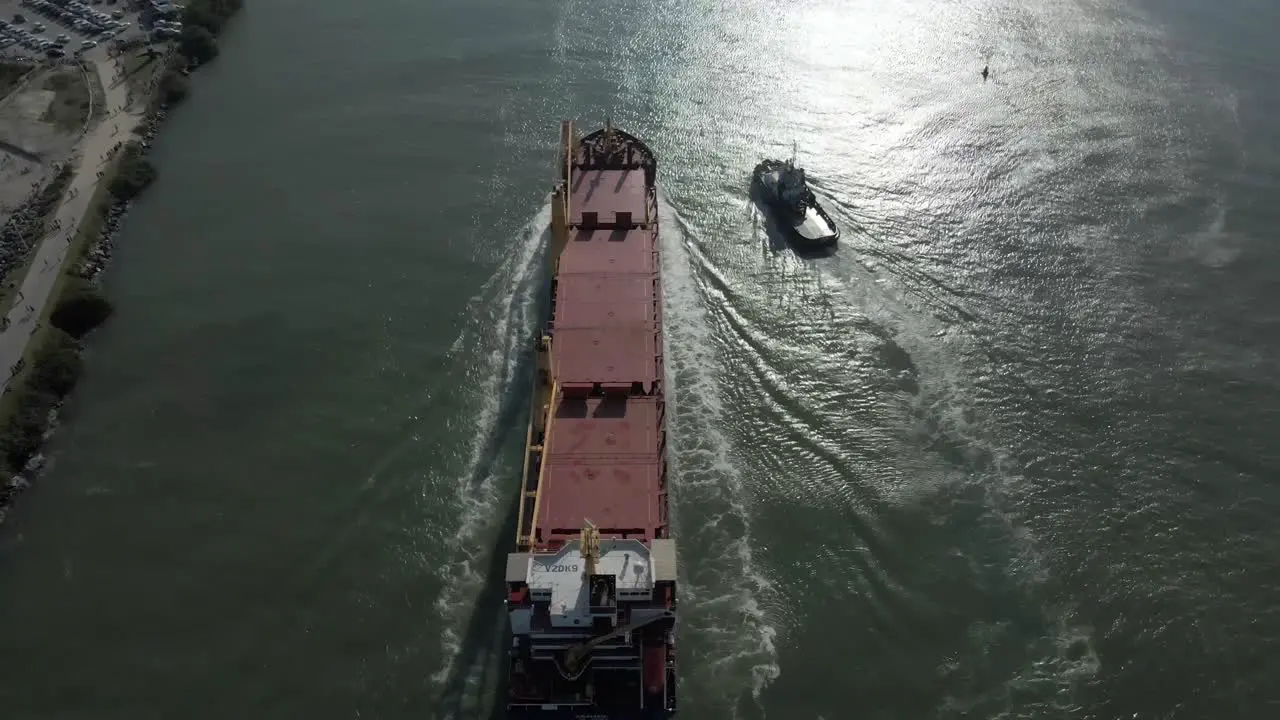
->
(0, 0, 242, 521)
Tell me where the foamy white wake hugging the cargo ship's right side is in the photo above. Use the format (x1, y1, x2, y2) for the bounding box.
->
(659, 200, 781, 716)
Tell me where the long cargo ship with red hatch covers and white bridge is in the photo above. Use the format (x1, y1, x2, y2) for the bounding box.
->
(506, 120, 677, 720)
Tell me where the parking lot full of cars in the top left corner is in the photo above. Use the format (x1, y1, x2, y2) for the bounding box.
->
(0, 0, 162, 59)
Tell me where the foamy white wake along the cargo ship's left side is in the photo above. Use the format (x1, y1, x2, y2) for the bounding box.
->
(431, 205, 550, 717)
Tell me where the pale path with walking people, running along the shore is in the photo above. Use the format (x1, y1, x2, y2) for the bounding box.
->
(0, 47, 143, 392)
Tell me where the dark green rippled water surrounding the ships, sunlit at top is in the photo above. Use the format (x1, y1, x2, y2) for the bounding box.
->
(0, 0, 1280, 720)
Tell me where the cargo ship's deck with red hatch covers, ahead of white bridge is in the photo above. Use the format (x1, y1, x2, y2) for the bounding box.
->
(522, 126, 668, 551)
